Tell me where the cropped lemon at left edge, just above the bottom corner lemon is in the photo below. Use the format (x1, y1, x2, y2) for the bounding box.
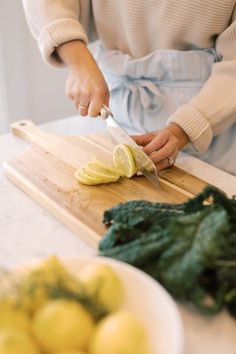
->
(0, 300, 29, 332)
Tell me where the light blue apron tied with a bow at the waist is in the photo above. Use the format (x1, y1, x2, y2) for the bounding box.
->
(94, 44, 236, 175)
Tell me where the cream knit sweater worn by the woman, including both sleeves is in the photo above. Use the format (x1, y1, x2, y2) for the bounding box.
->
(23, 0, 236, 152)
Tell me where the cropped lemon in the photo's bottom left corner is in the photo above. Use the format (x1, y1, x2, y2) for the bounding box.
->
(0, 329, 39, 354)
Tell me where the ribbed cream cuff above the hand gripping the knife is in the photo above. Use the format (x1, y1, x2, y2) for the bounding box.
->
(38, 18, 88, 66)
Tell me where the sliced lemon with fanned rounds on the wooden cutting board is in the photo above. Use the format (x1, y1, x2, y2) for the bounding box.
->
(75, 144, 153, 185)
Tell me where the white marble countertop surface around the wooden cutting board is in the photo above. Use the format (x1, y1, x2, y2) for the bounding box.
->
(0, 116, 236, 354)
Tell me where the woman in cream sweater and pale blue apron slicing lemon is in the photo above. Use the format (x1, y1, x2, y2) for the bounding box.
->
(23, 0, 236, 174)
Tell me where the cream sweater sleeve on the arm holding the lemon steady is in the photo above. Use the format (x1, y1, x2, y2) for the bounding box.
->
(168, 13, 236, 153)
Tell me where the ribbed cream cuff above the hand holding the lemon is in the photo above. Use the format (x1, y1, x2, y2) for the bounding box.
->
(167, 105, 213, 153)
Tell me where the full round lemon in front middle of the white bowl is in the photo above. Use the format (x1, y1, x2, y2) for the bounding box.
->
(32, 300, 94, 351)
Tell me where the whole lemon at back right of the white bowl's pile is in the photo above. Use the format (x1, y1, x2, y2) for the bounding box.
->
(79, 263, 123, 311)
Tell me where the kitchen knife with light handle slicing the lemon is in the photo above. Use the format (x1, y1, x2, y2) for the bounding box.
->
(100, 105, 160, 188)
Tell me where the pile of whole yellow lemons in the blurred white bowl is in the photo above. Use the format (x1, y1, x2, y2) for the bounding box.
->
(0, 257, 150, 354)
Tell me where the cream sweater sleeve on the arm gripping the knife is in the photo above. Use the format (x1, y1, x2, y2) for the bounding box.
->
(23, 0, 94, 66)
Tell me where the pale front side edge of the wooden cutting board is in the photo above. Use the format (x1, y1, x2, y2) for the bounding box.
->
(3, 161, 101, 250)
